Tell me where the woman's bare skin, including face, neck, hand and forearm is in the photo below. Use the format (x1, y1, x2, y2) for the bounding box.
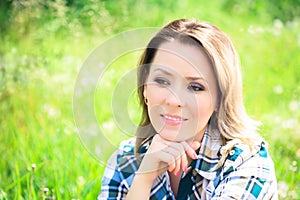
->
(127, 41, 217, 199)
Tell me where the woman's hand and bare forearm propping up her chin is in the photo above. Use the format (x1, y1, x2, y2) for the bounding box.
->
(126, 134, 200, 200)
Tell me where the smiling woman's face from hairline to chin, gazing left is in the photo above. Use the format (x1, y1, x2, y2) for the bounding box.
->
(144, 41, 217, 141)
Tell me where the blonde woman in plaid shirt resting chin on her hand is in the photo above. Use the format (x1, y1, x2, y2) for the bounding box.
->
(98, 19, 277, 199)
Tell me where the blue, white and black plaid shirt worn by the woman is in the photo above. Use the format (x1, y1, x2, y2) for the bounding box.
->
(98, 126, 278, 200)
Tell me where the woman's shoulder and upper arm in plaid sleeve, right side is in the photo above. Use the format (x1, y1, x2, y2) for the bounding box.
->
(214, 140, 277, 199)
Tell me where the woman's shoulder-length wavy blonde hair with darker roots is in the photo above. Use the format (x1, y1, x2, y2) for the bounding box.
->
(136, 19, 259, 166)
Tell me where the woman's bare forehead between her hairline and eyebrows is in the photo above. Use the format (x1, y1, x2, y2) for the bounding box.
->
(150, 41, 215, 81)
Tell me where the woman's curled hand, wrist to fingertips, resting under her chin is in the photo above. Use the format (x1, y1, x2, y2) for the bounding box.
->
(137, 134, 200, 183)
